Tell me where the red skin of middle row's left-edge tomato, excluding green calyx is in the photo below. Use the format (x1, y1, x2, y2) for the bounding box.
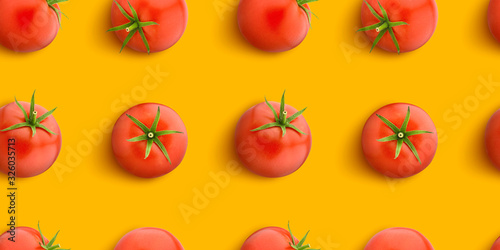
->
(0, 102, 62, 177)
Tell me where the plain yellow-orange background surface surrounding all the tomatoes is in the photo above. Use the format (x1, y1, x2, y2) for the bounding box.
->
(0, 0, 500, 250)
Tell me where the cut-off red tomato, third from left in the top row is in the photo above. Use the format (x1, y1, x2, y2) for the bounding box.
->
(238, 0, 317, 52)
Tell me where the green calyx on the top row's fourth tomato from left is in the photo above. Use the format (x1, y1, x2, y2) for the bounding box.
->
(358, 1, 408, 54)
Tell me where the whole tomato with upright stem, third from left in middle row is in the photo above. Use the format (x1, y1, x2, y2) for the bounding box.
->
(235, 93, 311, 177)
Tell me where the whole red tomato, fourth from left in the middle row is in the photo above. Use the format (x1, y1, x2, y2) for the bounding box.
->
(362, 103, 437, 178)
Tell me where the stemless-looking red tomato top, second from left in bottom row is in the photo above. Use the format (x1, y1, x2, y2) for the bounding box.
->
(115, 227, 184, 250)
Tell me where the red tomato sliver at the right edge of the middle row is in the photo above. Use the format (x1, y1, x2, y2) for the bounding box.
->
(485, 110, 500, 169)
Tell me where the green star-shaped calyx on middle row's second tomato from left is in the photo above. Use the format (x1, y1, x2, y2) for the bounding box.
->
(127, 106, 182, 164)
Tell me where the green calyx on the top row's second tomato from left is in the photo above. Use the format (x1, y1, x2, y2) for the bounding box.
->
(108, 1, 158, 54)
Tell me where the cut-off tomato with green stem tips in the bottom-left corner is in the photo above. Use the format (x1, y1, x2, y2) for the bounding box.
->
(0, 225, 68, 250)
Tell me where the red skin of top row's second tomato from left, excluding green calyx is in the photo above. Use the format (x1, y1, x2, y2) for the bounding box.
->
(111, 0, 188, 53)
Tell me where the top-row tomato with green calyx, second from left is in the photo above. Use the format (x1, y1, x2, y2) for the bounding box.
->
(108, 0, 188, 53)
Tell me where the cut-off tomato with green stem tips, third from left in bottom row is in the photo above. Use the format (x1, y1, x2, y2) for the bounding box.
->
(241, 225, 312, 250)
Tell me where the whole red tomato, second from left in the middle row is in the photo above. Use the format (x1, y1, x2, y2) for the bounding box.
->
(111, 103, 187, 178)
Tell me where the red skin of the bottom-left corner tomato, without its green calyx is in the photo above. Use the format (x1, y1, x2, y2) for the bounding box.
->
(0, 227, 49, 250)
